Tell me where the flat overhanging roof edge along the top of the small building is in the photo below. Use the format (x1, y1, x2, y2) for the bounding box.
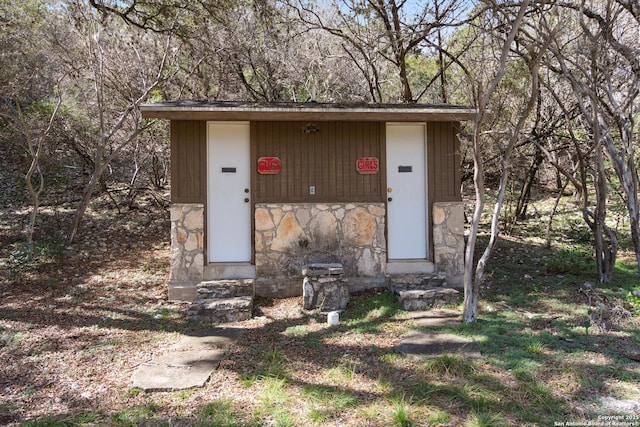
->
(140, 101, 477, 122)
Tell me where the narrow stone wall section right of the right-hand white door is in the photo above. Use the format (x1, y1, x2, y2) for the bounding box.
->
(433, 202, 464, 287)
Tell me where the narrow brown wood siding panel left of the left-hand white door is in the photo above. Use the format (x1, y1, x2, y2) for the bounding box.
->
(171, 120, 207, 203)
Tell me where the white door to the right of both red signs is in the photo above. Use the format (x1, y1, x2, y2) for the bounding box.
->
(387, 123, 427, 260)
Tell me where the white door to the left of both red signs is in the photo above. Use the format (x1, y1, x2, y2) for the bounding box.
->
(207, 122, 251, 263)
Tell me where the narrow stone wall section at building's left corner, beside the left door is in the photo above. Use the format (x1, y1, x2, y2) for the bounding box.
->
(168, 203, 205, 301)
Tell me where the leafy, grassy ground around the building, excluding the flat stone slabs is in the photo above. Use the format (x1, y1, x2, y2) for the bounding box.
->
(0, 182, 640, 426)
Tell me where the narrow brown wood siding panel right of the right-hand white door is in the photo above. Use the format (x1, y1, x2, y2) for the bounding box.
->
(427, 122, 461, 202)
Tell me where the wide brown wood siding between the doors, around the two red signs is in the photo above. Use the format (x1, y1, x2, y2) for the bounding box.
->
(251, 121, 386, 203)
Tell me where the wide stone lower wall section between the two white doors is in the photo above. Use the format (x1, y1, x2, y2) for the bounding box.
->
(255, 203, 387, 296)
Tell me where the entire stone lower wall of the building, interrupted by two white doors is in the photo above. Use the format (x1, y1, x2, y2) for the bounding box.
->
(169, 202, 465, 301)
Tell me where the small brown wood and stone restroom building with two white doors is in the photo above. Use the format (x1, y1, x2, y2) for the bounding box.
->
(141, 101, 475, 300)
